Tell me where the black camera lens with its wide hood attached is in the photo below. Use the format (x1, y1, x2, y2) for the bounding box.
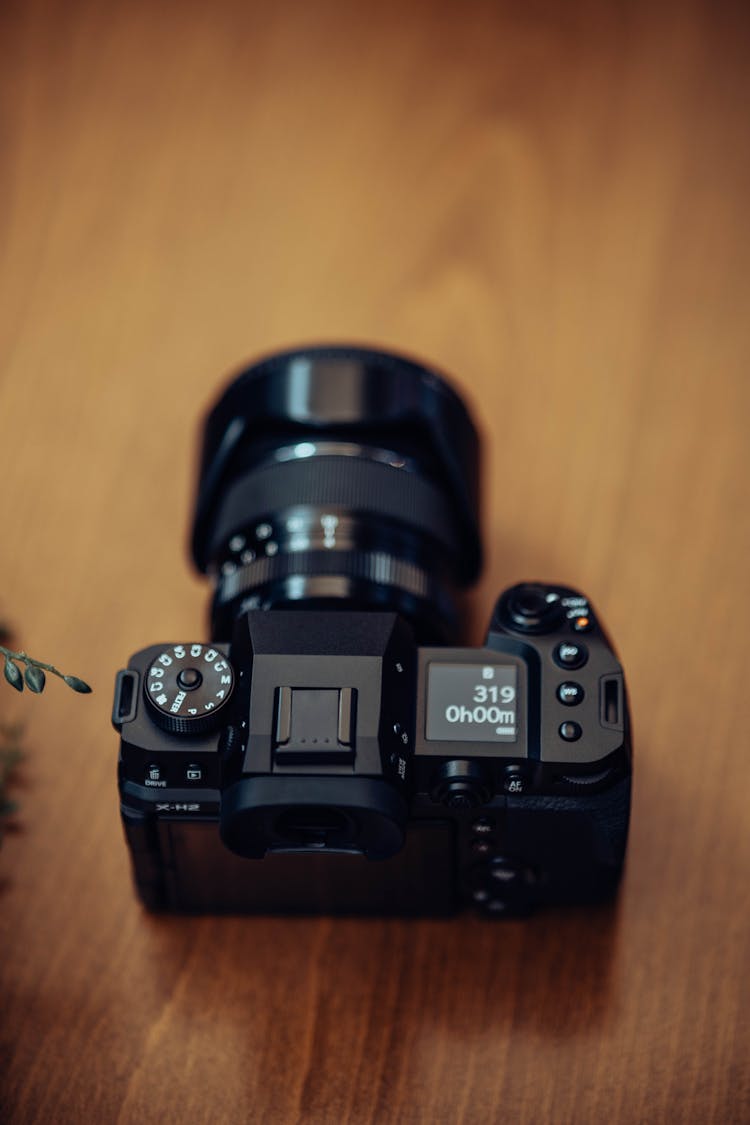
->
(192, 347, 480, 644)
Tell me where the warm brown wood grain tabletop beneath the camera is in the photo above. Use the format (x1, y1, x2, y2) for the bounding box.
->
(0, 0, 750, 1125)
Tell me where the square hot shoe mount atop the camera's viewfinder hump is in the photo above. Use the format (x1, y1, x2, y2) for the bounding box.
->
(273, 686, 356, 765)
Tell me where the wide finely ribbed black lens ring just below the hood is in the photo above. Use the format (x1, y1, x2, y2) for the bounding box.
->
(209, 457, 461, 555)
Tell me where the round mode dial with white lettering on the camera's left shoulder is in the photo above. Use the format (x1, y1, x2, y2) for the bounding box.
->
(144, 645, 234, 735)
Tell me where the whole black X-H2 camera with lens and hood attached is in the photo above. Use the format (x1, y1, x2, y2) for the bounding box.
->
(112, 347, 631, 917)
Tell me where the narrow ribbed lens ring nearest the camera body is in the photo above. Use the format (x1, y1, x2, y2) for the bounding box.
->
(216, 551, 439, 605)
